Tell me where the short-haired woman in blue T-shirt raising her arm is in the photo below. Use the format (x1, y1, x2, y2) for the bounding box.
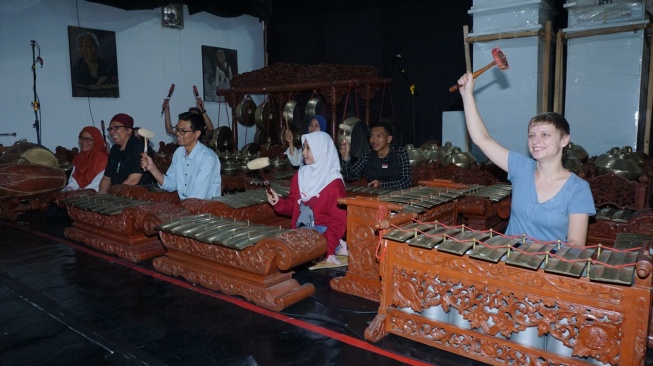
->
(458, 73, 596, 246)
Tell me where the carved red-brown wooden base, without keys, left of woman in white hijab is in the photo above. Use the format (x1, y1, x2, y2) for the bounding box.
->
(153, 229, 326, 311)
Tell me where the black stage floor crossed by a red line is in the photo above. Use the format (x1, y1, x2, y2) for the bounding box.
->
(0, 212, 653, 366)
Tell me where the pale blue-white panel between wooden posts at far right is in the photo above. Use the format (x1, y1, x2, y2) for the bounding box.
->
(565, 30, 646, 156)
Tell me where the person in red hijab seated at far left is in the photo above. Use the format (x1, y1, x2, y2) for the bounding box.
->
(63, 126, 109, 192)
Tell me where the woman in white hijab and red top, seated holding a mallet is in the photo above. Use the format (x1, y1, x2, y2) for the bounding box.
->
(268, 131, 347, 264)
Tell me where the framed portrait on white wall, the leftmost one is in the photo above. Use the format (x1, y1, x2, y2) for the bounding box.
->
(68, 26, 120, 98)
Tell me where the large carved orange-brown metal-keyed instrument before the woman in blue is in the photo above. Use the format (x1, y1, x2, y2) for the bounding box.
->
(350, 193, 653, 365)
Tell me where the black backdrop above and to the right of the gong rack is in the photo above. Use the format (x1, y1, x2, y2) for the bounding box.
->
(267, 0, 566, 146)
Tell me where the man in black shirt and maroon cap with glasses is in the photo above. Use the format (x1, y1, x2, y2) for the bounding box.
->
(98, 113, 154, 194)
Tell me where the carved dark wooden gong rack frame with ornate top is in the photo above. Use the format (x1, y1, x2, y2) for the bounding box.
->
(216, 63, 392, 146)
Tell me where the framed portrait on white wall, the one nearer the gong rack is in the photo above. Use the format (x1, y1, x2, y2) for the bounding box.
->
(202, 46, 238, 102)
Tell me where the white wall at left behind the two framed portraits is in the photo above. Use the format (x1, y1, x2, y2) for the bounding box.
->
(0, 0, 264, 151)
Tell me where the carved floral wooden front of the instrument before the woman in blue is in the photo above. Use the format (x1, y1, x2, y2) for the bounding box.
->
(348, 196, 653, 365)
